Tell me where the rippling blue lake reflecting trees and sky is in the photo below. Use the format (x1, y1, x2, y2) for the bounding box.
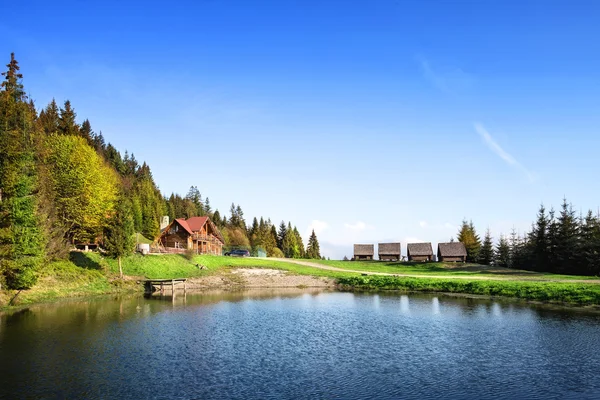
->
(0, 289, 600, 399)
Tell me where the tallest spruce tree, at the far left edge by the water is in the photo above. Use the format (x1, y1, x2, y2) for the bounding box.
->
(0, 54, 45, 290)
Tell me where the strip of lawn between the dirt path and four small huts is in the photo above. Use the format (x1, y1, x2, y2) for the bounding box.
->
(310, 260, 598, 280)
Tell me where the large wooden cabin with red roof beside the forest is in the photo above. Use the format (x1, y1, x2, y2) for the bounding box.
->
(159, 217, 225, 255)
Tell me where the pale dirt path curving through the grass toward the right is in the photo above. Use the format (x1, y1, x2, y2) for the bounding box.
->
(274, 258, 600, 284)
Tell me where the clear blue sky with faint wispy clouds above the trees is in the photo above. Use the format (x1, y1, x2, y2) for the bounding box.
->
(0, 0, 600, 258)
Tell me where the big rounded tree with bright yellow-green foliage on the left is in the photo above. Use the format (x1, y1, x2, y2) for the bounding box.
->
(45, 135, 118, 241)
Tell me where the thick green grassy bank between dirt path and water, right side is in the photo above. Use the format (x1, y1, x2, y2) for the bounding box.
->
(338, 276, 600, 305)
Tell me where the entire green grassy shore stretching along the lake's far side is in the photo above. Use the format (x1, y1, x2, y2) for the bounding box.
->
(0, 252, 600, 307)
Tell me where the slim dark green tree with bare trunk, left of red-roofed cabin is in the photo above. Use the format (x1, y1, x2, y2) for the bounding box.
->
(104, 198, 135, 279)
